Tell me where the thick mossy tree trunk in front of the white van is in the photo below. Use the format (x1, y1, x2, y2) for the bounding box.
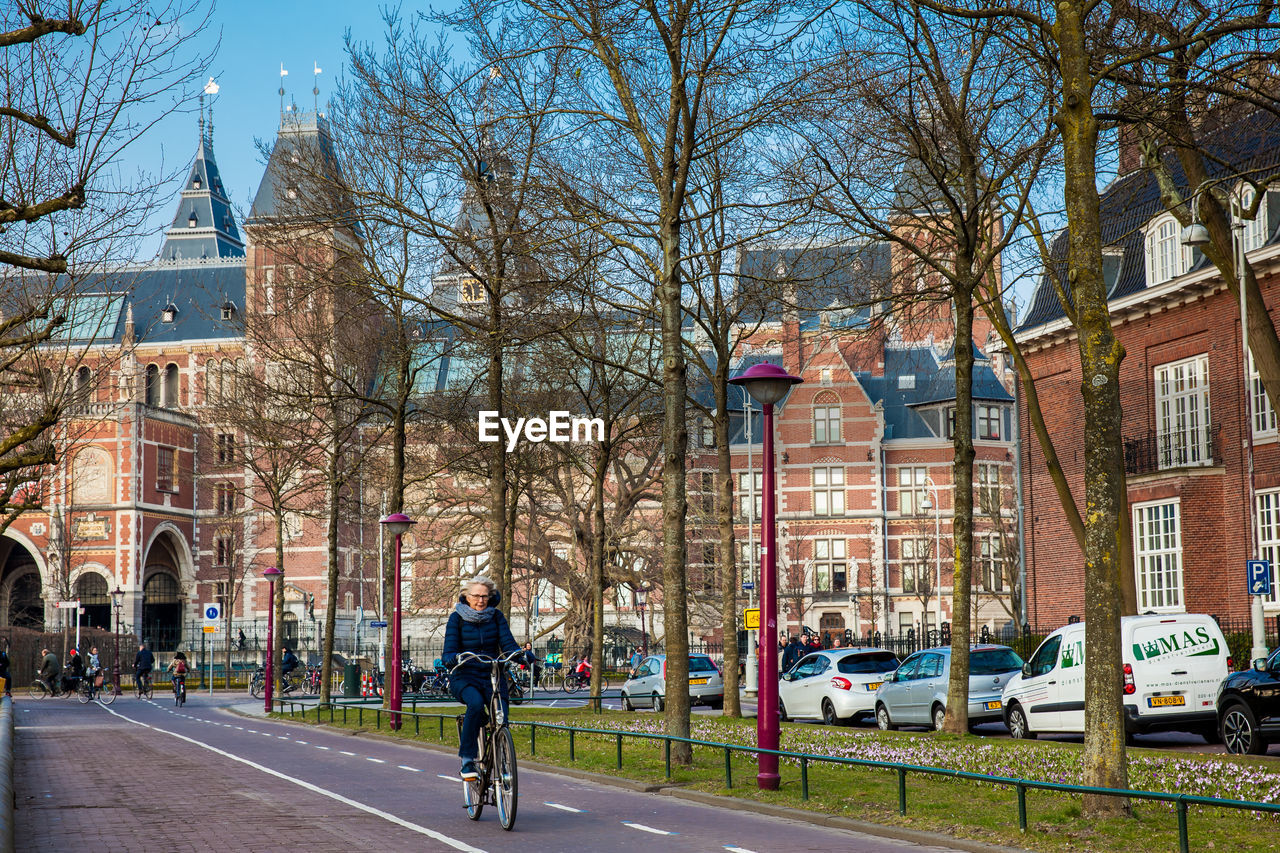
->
(1055, 8, 1129, 817)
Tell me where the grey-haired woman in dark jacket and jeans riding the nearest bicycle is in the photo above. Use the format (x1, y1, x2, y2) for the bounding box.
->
(440, 575, 520, 780)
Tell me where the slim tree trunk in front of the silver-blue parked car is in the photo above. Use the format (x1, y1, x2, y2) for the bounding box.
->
(938, 284, 973, 734)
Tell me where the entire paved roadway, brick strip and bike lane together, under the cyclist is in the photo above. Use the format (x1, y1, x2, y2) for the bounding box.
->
(15, 693, 967, 853)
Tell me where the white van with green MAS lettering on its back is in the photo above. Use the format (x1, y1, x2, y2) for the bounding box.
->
(1002, 613, 1230, 742)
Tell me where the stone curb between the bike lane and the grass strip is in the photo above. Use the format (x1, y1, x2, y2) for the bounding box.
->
(259, 708, 1025, 853)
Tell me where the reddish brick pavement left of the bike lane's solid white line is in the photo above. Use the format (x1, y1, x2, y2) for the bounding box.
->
(14, 698, 434, 853)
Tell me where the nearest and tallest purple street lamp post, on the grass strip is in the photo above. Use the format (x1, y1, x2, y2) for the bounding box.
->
(730, 364, 804, 790)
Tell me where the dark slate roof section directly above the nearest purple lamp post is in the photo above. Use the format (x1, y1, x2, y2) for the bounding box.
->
(737, 242, 890, 329)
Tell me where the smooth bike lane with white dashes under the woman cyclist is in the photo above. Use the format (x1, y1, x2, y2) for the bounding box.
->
(94, 702, 972, 853)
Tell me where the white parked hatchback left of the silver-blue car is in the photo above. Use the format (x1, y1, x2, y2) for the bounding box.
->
(778, 648, 899, 726)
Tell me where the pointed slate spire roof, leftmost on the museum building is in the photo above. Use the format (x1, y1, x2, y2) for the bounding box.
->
(160, 122, 244, 261)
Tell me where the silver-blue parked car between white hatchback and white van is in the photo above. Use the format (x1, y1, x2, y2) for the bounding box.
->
(876, 646, 1023, 730)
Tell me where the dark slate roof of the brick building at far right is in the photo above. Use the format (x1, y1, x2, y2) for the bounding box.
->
(1018, 110, 1280, 330)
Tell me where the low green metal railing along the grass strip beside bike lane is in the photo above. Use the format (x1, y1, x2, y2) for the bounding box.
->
(278, 697, 1280, 853)
